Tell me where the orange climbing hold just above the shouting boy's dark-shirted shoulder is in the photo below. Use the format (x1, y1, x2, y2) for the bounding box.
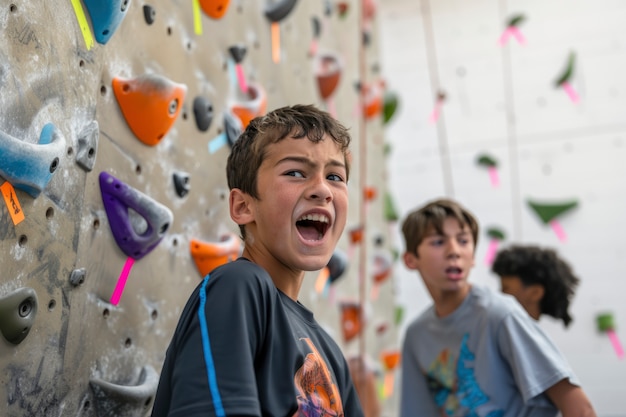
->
(189, 234, 241, 277)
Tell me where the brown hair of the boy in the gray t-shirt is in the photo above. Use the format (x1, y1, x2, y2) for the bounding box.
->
(402, 198, 479, 255)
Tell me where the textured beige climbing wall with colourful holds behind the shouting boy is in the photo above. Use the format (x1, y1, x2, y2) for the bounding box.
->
(0, 0, 397, 417)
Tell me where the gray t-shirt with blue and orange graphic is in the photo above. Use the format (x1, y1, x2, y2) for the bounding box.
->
(400, 286, 579, 417)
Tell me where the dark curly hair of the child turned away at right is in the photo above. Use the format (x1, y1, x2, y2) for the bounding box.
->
(491, 245, 580, 327)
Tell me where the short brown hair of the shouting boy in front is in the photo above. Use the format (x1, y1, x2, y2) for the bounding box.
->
(226, 104, 351, 238)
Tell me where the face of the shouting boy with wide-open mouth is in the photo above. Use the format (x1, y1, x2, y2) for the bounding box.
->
(241, 136, 348, 271)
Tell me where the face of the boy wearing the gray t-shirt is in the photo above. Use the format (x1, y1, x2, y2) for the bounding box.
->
(404, 217, 474, 297)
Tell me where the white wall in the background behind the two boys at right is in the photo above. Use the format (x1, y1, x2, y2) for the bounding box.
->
(378, 0, 626, 417)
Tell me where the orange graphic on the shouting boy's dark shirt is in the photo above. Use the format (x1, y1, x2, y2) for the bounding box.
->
(294, 338, 343, 417)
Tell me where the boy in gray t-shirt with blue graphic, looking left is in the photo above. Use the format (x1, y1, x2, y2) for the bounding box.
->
(400, 199, 596, 417)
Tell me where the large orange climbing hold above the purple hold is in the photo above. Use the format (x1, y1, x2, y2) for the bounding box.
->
(113, 74, 187, 146)
